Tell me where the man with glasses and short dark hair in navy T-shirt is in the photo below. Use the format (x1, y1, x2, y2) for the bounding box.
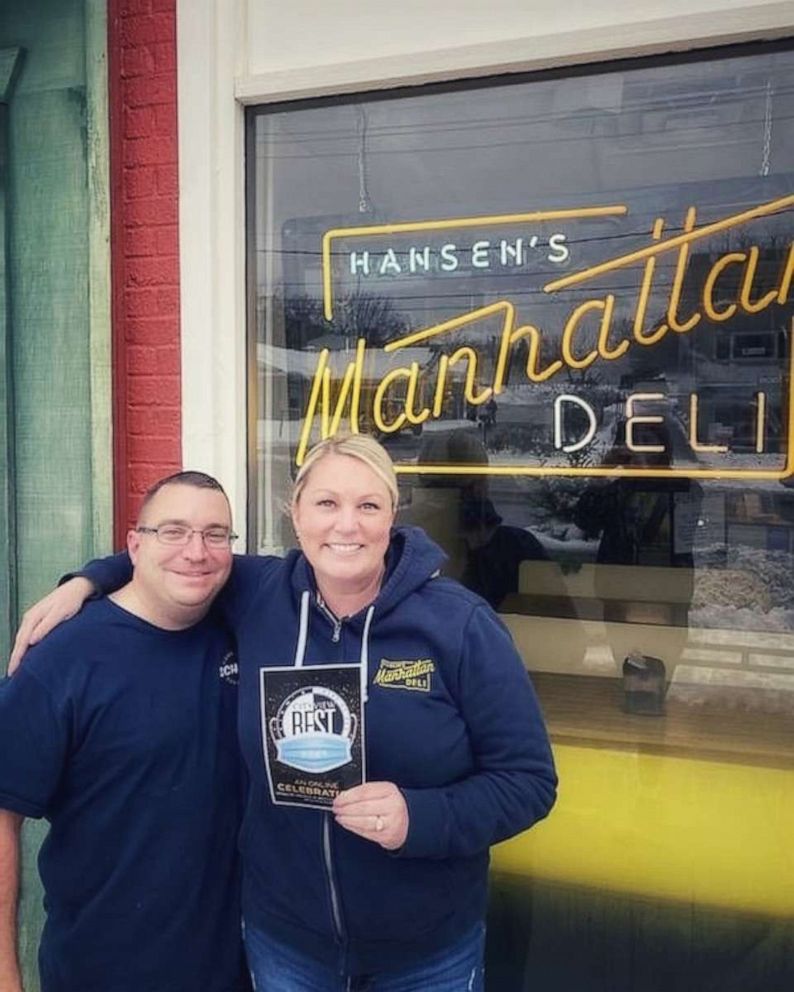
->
(0, 472, 248, 992)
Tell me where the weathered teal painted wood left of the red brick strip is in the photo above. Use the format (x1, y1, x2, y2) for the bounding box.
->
(0, 0, 112, 992)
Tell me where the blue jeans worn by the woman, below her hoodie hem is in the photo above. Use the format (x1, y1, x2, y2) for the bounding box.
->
(245, 923, 485, 992)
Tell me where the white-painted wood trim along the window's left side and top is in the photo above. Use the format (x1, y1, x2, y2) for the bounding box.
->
(177, 0, 794, 541)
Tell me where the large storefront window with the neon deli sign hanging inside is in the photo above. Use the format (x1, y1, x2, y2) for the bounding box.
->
(247, 45, 794, 990)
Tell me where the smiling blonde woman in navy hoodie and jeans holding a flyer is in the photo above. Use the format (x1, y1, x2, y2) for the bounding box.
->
(13, 435, 556, 992)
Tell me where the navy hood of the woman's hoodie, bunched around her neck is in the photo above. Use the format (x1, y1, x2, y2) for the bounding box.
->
(285, 527, 447, 622)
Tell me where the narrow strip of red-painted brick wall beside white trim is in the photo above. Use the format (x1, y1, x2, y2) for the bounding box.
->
(108, 0, 181, 546)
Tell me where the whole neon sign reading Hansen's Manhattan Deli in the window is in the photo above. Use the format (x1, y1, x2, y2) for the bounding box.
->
(296, 195, 794, 479)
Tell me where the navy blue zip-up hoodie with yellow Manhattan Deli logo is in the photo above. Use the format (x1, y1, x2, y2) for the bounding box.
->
(77, 527, 557, 974)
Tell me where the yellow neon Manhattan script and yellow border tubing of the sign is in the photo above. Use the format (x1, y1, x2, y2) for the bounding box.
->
(296, 195, 794, 478)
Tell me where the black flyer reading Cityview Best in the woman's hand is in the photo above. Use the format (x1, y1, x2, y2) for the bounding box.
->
(259, 664, 366, 809)
